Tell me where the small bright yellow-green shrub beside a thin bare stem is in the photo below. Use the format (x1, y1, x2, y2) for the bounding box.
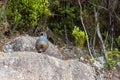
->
(72, 26, 88, 47)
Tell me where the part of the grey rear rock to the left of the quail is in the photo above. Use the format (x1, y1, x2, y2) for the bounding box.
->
(3, 36, 37, 53)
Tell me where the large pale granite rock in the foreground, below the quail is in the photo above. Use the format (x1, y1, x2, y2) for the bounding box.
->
(0, 52, 95, 80)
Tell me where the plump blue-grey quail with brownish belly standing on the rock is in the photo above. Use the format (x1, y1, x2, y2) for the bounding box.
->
(35, 32, 49, 53)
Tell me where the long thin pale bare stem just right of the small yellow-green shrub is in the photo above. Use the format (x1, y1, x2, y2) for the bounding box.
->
(78, 0, 94, 58)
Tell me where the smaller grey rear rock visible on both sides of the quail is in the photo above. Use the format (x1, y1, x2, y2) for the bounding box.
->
(3, 36, 62, 59)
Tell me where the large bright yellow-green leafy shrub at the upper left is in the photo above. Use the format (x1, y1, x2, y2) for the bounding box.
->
(6, 0, 50, 29)
